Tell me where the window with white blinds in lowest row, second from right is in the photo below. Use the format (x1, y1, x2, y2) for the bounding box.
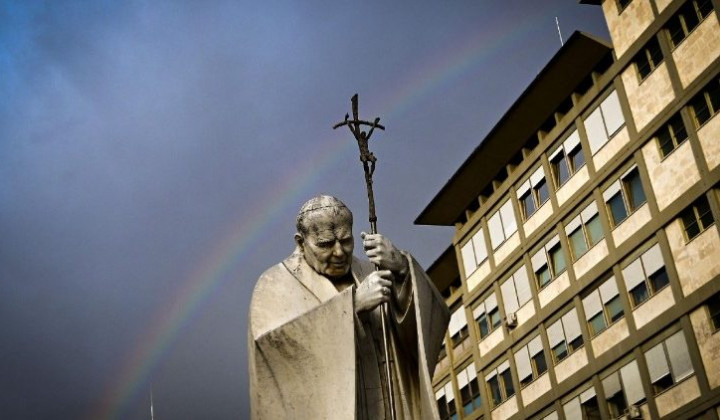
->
(602, 360, 645, 418)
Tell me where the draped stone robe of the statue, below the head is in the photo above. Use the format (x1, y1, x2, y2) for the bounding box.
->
(248, 251, 450, 420)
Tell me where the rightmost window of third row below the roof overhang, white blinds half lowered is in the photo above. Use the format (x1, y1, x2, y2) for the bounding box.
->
(622, 244, 670, 307)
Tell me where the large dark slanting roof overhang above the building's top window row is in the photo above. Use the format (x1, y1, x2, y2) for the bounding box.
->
(415, 31, 612, 226)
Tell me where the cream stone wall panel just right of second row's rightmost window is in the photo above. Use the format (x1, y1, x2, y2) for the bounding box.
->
(642, 138, 700, 211)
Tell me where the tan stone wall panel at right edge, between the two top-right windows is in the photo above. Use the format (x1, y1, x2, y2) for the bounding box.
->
(672, 13, 720, 87)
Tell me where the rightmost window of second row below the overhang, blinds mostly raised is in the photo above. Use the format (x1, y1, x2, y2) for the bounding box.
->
(603, 166, 647, 226)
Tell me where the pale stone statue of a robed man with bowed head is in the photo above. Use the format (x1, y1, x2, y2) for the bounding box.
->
(248, 196, 450, 420)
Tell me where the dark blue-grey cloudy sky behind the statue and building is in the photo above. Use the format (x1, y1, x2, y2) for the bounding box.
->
(0, 0, 607, 420)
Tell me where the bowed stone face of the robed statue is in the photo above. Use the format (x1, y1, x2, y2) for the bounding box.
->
(295, 210, 355, 279)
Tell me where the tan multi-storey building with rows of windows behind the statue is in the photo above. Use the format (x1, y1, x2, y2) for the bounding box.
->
(416, 0, 720, 420)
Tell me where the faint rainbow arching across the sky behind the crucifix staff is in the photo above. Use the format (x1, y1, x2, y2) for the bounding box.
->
(90, 5, 552, 419)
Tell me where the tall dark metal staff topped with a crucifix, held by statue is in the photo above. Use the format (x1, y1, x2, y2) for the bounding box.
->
(333, 93, 397, 420)
